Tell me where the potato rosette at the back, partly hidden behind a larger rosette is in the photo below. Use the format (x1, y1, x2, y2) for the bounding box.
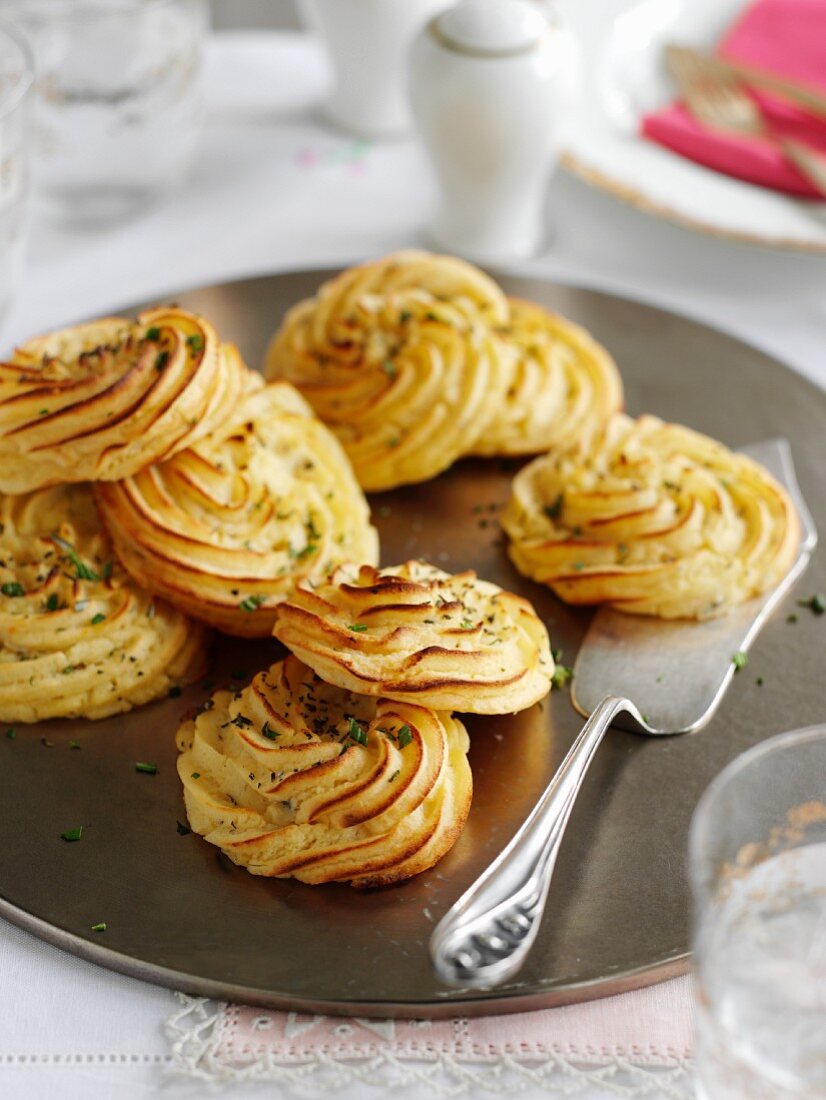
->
(473, 298, 623, 455)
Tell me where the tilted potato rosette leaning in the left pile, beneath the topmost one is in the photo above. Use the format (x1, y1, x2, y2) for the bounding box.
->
(95, 382, 378, 637)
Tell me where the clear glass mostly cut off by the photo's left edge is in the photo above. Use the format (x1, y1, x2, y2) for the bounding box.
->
(0, 19, 34, 331)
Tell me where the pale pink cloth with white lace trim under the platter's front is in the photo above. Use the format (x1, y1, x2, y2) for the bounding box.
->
(167, 977, 694, 1100)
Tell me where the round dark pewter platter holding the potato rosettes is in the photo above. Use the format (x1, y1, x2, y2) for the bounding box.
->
(0, 272, 826, 1016)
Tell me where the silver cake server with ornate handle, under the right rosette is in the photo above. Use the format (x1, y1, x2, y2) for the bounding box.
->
(430, 439, 817, 989)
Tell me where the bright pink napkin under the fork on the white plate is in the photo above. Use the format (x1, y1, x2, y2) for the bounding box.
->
(641, 0, 826, 199)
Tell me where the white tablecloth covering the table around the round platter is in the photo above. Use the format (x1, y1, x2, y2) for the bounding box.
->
(0, 25, 826, 1100)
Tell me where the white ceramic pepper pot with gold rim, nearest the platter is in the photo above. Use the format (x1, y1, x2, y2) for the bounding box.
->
(409, 0, 575, 263)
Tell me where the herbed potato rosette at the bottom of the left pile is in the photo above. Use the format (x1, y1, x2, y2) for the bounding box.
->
(0, 485, 206, 722)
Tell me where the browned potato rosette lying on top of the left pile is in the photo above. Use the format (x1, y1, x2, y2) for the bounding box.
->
(0, 309, 249, 493)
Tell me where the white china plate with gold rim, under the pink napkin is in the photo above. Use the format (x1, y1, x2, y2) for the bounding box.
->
(562, 0, 826, 252)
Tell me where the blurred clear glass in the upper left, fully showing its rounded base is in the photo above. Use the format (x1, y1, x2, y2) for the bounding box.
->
(0, 0, 209, 227)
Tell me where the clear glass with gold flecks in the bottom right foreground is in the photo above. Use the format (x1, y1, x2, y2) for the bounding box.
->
(691, 726, 826, 1100)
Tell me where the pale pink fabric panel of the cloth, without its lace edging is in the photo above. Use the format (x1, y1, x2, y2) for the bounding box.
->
(203, 977, 693, 1070)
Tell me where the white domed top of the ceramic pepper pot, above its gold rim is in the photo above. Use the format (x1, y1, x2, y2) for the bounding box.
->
(432, 0, 548, 56)
